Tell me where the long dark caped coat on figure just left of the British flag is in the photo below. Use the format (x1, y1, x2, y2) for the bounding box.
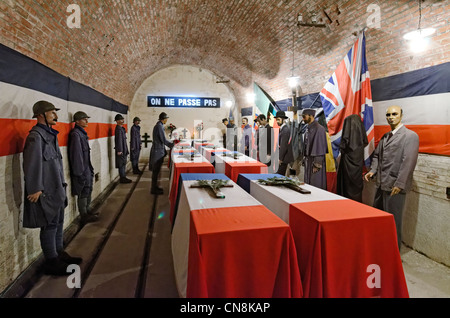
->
(303, 118, 328, 190)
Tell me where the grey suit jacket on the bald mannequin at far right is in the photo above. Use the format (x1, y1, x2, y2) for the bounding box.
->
(370, 126, 419, 193)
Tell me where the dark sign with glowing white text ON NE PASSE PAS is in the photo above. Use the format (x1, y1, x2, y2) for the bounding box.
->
(147, 96, 220, 108)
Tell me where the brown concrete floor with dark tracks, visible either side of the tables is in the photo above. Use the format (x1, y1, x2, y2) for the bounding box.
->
(18, 165, 450, 298)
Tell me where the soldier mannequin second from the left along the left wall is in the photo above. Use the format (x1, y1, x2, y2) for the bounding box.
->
(68, 111, 98, 225)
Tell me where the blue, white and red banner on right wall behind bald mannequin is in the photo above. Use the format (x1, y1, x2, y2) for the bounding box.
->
(371, 62, 450, 156)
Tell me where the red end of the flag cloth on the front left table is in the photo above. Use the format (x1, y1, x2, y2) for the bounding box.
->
(186, 205, 303, 298)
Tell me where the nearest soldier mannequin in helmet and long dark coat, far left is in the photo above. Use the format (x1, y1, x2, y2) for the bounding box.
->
(23, 101, 82, 276)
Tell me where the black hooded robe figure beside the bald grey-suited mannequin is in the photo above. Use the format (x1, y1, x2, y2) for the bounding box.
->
(337, 114, 368, 202)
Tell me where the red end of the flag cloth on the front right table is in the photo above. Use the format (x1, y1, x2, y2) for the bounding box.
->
(289, 200, 409, 298)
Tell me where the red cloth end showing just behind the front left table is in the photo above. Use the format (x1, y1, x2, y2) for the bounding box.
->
(169, 162, 214, 223)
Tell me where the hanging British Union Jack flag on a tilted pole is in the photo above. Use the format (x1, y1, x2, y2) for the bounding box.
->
(320, 32, 375, 166)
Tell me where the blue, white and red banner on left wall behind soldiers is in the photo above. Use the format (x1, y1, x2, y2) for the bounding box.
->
(0, 44, 128, 157)
